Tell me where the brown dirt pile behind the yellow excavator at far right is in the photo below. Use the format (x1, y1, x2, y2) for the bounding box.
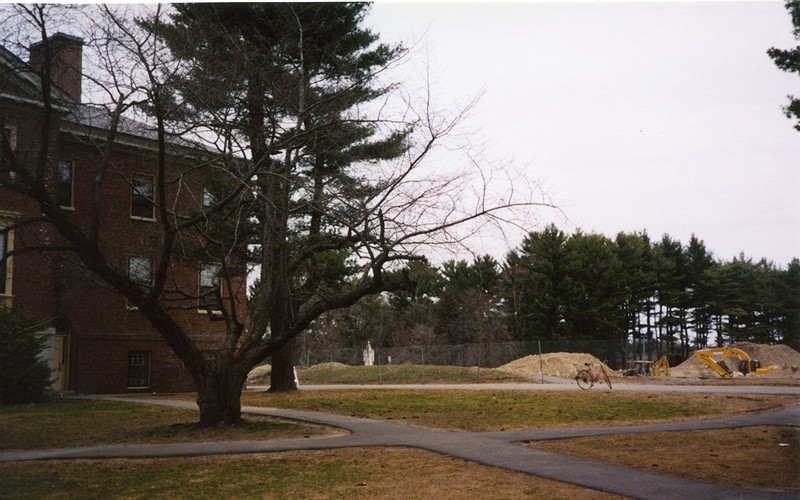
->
(669, 342, 800, 379)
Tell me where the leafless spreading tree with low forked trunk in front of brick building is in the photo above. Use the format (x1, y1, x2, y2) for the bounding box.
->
(3, 4, 546, 425)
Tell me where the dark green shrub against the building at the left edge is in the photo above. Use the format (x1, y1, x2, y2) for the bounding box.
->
(0, 307, 50, 404)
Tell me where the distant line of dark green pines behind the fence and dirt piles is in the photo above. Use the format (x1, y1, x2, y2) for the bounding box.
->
(302, 225, 800, 361)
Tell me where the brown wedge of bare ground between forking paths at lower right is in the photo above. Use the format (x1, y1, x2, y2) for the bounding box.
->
(529, 427, 800, 491)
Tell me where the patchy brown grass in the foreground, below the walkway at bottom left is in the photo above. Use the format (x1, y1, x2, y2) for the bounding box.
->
(0, 448, 620, 500)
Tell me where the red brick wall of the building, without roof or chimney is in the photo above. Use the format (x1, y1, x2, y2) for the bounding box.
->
(0, 86, 246, 393)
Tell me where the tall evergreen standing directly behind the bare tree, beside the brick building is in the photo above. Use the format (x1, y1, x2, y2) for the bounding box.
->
(155, 3, 407, 391)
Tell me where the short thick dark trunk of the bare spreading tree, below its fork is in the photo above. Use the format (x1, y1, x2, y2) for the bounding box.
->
(197, 369, 247, 427)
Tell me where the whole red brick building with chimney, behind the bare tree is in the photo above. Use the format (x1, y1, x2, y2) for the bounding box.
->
(0, 34, 245, 393)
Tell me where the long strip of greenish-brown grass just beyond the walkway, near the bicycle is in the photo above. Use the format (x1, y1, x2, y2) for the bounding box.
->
(242, 389, 797, 432)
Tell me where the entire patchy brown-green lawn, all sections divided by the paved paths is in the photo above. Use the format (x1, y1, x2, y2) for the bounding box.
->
(0, 390, 800, 499)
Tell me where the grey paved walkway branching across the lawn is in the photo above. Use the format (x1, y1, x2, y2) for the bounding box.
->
(0, 397, 800, 499)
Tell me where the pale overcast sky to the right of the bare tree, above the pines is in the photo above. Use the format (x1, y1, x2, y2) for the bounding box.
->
(367, 1, 800, 267)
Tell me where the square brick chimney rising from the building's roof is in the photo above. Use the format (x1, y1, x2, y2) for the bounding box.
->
(29, 33, 83, 102)
